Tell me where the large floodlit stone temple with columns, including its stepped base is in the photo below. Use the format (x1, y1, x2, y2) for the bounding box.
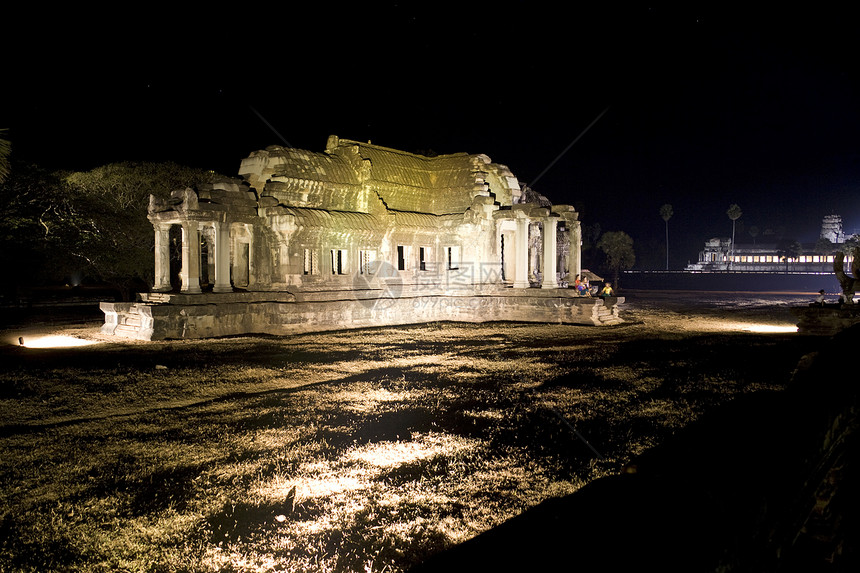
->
(101, 136, 623, 340)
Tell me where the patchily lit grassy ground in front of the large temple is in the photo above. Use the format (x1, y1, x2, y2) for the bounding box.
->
(0, 294, 814, 572)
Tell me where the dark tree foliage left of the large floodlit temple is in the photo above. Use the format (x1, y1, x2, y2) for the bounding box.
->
(0, 162, 214, 299)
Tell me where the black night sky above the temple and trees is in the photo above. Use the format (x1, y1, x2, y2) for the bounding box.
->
(6, 2, 860, 268)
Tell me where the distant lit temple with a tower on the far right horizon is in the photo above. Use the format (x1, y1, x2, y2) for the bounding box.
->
(685, 215, 852, 274)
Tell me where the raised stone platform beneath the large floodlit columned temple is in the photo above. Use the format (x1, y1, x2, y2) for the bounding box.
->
(100, 285, 624, 340)
